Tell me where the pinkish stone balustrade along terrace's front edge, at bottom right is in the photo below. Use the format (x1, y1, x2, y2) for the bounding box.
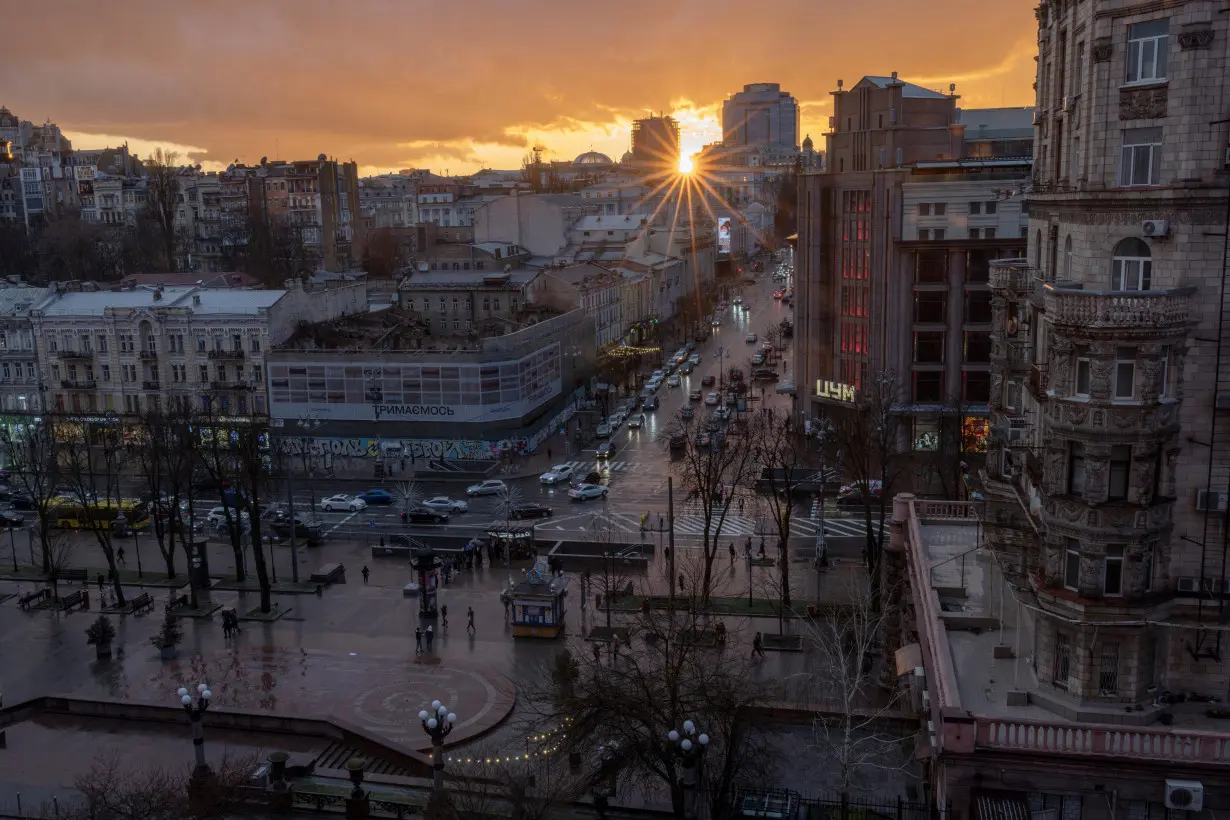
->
(977, 718, 1230, 763)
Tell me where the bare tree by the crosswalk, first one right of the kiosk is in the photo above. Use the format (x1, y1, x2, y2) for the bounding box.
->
(663, 414, 755, 606)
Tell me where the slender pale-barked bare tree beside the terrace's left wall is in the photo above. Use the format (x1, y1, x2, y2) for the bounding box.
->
(804, 584, 909, 794)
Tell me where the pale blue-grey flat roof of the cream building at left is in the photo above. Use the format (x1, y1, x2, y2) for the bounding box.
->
(39, 285, 287, 318)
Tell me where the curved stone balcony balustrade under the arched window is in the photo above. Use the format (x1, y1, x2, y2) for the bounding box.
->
(1046, 285, 1196, 329)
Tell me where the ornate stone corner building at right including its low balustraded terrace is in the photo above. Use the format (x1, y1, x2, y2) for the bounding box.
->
(889, 0, 1230, 820)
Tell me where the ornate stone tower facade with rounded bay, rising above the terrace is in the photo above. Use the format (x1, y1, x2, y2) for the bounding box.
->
(985, 0, 1230, 712)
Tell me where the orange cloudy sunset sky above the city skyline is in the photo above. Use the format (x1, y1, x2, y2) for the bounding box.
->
(0, 0, 1037, 173)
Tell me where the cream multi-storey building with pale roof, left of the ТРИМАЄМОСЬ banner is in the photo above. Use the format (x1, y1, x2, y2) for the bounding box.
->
(28, 284, 367, 427)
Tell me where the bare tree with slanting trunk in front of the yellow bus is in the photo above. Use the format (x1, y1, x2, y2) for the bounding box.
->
(50, 419, 125, 606)
